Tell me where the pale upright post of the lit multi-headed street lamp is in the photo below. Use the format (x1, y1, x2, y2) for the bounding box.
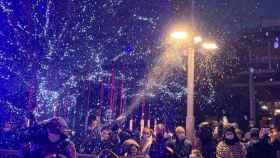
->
(186, 48, 195, 138)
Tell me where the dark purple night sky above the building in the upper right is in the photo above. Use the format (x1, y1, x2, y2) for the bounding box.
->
(195, 0, 280, 35)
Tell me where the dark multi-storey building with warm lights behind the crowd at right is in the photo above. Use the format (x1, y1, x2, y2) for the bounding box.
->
(229, 25, 280, 124)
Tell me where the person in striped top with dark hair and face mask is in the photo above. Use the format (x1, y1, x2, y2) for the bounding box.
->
(216, 125, 246, 158)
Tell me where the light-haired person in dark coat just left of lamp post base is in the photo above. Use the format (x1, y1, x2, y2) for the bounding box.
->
(172, 126, 192, 158)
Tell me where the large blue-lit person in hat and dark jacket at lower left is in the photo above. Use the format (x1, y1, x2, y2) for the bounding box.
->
(20, 117, 76, 158)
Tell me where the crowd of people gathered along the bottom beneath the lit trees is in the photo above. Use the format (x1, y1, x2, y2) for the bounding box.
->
(0, 117, 280, 158)
